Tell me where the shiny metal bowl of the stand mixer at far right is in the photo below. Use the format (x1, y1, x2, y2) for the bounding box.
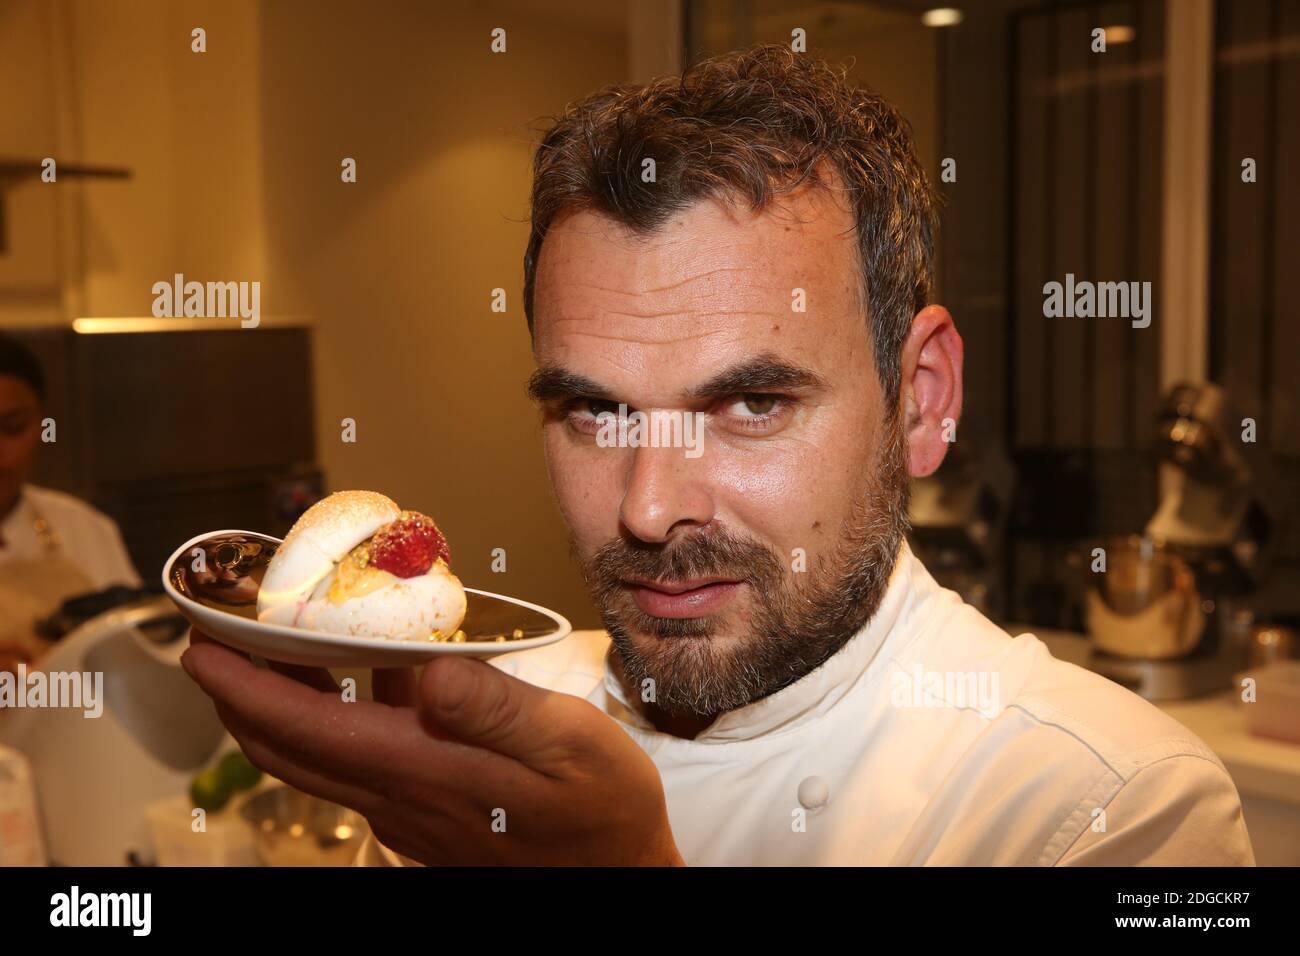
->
(1084, 535, 1206, 659)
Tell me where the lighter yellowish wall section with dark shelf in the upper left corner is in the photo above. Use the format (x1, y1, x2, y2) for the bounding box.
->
(0, 0, 265, 325)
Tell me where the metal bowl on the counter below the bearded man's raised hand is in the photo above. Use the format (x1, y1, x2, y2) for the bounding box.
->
(239, 784, 368, 866)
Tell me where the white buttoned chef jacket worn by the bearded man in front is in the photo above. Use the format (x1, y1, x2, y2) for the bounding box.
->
(358, 544, 1255, 866)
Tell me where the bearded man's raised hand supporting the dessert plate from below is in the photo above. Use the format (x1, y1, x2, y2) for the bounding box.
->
(181, 631, 683, 865)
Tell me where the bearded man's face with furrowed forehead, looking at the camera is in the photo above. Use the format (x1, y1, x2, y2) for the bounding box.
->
(533, 190, 906, 715)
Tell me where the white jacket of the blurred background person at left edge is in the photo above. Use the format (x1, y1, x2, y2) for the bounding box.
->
(0, 484, 140, 597)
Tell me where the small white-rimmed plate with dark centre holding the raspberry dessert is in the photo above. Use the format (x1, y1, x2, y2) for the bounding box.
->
(163, 531, 573, 667)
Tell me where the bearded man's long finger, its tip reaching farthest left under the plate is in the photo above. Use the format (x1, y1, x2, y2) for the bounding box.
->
(181, 645, 482, 788)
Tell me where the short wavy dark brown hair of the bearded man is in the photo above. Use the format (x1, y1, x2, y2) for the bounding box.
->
(524, 44, 937, 410)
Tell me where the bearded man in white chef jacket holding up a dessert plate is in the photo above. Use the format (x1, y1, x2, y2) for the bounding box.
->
(185, 47, 1253, 865)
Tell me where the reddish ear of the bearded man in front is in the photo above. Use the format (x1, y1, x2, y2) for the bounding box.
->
(901, 306, 963, 477)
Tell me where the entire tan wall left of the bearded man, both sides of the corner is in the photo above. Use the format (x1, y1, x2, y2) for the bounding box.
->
(0, 0, 650, 626)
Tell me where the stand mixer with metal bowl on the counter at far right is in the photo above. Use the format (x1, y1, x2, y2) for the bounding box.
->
(1084, 384, 1277, 700)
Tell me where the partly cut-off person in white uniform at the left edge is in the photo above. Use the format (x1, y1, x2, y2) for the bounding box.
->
(0, 333, 140, 670)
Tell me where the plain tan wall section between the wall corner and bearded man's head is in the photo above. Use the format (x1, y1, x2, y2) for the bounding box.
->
(260, 1, 628, 624)
